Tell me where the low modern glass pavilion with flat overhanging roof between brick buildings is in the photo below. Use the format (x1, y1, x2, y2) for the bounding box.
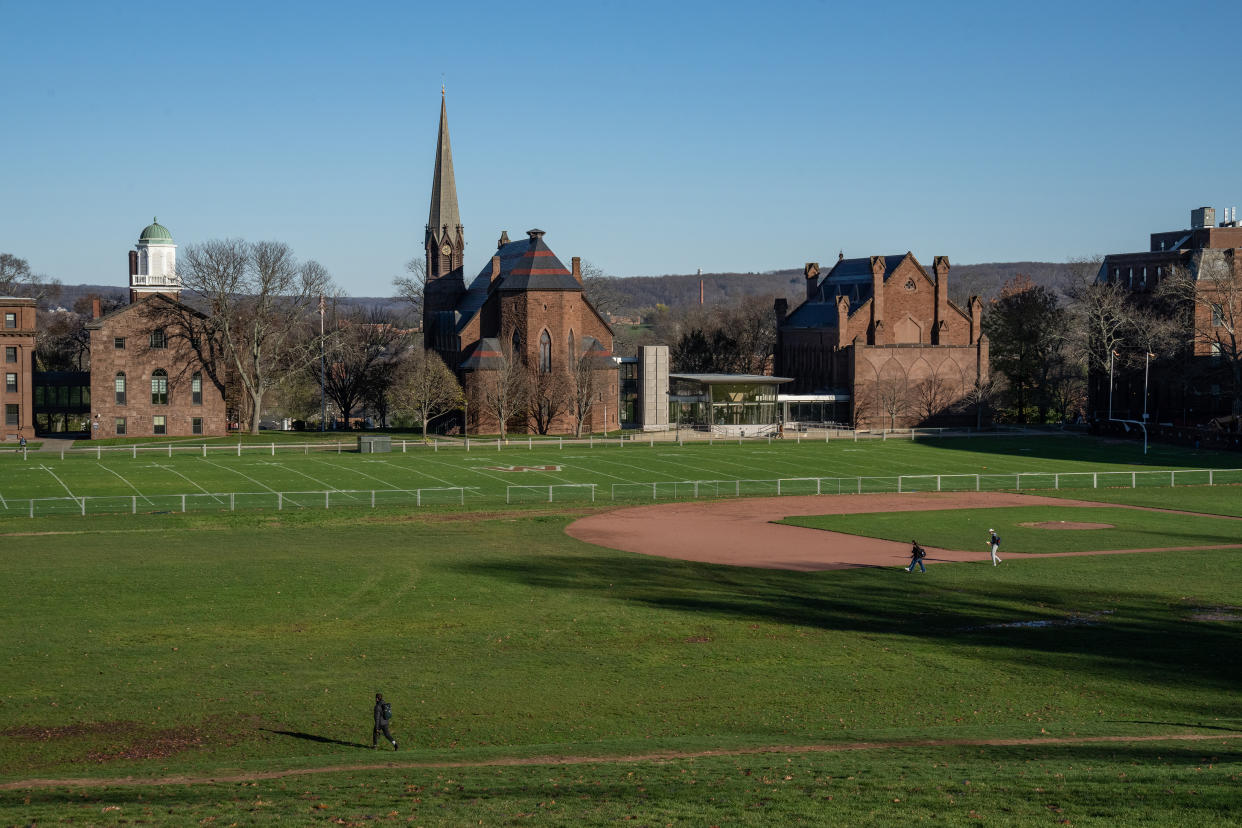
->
(668, 374, 794, 434)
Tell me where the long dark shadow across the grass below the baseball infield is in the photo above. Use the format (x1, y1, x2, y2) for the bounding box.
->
(453, 554, 1242, 700)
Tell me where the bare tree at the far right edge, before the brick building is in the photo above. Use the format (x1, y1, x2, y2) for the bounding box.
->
(1156, 250, 1242, 427)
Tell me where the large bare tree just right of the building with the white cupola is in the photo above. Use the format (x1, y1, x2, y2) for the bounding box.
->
(178, 238, 332, 433)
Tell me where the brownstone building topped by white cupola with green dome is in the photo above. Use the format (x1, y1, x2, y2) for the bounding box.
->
(86, 221, 227, 438)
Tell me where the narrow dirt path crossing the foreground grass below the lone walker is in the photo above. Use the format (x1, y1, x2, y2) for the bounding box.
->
(0, 732, 1242, 791)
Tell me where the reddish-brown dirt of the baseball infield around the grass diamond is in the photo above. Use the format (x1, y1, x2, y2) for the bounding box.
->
(565, 492, 1242, 572)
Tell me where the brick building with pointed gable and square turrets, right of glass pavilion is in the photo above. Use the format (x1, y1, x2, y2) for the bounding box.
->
(775, 253, 989, 427)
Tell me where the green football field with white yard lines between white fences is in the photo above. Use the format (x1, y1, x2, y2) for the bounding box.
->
(7, 436, 1242, 514)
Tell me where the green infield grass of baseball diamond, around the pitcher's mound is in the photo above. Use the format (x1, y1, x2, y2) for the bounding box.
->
(781, 506, 1242, 556)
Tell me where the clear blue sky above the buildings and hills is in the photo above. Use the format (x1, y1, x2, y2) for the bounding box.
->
(0, 0, 1242, 295)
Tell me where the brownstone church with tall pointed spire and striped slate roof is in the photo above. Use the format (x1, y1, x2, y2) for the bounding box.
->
(422, 97, 620, 433)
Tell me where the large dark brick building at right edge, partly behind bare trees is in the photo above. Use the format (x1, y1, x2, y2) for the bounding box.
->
(1088, 207, 1242, 425)
